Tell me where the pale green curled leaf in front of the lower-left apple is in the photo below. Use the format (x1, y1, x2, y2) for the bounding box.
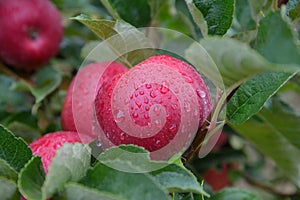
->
(42, 143, 91, 198)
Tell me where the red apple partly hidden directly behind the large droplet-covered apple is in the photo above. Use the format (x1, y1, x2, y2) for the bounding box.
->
(61, 62, 128, 142)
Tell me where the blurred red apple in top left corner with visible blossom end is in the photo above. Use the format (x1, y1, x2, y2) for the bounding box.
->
(0, 0, 63, 71)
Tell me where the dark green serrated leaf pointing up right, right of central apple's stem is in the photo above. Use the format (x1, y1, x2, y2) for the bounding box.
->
(226, 72, 293, 124)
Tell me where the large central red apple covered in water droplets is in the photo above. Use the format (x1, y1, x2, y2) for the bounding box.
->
(95, 55, 212, 159)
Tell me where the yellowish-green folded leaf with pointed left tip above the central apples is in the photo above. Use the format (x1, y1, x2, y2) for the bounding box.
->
(73, 15, 155, 67)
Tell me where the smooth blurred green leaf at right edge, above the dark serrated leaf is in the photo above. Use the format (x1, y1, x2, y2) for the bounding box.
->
(255, 11, 300, 65)
